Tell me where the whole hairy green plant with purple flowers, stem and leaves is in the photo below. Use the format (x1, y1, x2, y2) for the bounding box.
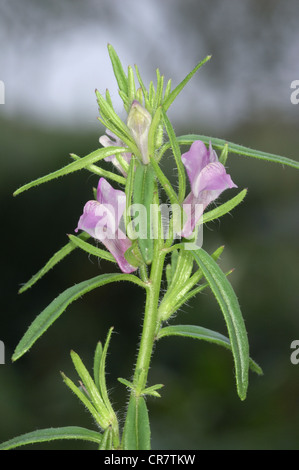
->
(0, 45, 299, 450)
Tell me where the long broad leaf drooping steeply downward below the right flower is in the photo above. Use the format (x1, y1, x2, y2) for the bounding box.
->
(193, 249, 249, 400)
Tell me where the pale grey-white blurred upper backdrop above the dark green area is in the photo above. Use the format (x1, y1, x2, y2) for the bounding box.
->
(0, 0, 299, 131)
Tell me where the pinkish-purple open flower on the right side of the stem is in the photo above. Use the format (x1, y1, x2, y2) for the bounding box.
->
(180, 140, 237, 238)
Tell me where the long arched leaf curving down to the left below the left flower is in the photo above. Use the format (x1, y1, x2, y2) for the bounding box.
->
(12, 273, 144, 361)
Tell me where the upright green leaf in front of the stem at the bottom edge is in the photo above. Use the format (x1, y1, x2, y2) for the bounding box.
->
(123, 393, 151, 450)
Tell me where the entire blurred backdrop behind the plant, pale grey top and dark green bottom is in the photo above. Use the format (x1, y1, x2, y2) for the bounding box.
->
(0, 0, 299, 449)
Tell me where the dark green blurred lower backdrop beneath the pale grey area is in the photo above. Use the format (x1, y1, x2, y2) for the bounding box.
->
(0, 113, 299, 449)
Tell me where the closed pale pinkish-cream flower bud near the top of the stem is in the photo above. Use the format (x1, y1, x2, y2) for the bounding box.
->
(127, 100, 152, 165)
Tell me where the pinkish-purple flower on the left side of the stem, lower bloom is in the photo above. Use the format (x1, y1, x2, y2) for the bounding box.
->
(75, 178, 136, 273)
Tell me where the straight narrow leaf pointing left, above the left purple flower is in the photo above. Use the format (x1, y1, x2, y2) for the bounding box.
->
(13, 147, 128, 196)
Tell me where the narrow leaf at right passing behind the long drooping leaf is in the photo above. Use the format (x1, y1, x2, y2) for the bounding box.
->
(157, 325, 263, 375)
